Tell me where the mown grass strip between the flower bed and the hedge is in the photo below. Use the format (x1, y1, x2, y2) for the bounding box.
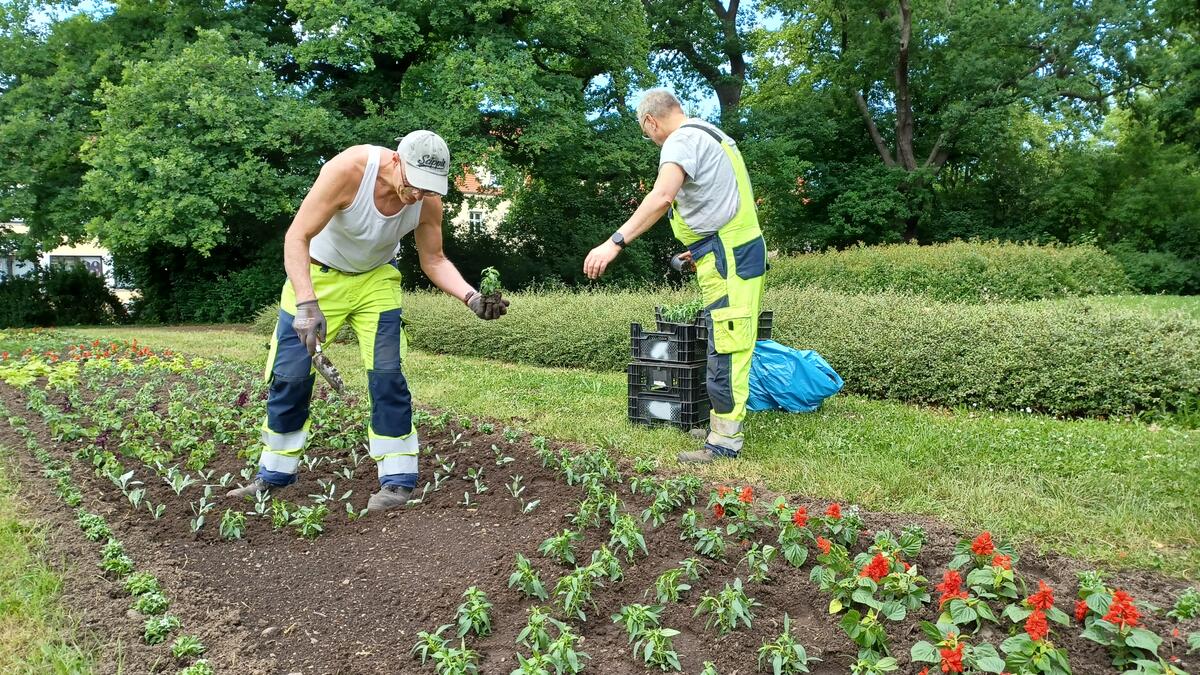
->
(68, 328, 1200, 579)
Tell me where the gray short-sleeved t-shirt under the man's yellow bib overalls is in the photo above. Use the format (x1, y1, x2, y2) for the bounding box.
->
(659, 118, 738, 234)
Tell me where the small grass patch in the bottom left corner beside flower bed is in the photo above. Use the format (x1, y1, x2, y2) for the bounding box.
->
(0, 448, 92, 675)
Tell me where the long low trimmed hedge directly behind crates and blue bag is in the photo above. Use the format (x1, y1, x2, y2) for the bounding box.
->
(404, 287, 1200, 416)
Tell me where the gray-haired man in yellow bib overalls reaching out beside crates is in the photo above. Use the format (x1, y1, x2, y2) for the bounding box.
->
(583, 89, 767, 462)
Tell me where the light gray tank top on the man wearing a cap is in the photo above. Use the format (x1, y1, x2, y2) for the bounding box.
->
(308, 145, 421, 274)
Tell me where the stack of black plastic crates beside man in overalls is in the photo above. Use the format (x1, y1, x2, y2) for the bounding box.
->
(628, 307, 772, 430)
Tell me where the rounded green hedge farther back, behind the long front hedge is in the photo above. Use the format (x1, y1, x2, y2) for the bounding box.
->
(767, 241, 1130, 297)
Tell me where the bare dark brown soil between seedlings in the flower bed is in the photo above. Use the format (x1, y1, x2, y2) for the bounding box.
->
(0, 386, 1200, 675)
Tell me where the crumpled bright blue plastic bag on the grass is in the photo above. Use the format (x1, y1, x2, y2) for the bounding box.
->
(746, 340, 842, 412)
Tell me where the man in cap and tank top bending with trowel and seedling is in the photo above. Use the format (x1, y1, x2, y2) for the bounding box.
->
(228, 131, 508, 512)
